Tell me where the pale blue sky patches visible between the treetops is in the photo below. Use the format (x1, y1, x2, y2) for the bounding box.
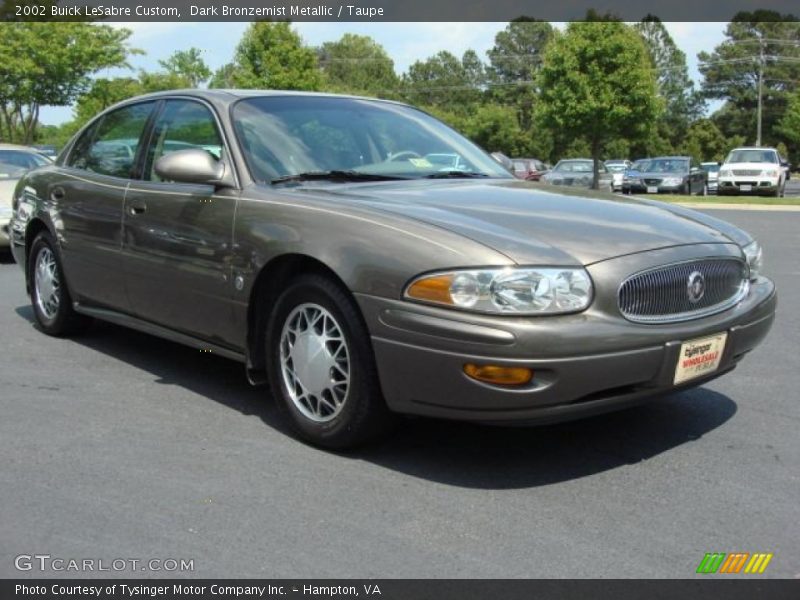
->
(41, 22, 727, 125)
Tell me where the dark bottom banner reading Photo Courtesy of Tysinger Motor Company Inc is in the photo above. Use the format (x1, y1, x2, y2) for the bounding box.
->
(0, 578, 800, 600)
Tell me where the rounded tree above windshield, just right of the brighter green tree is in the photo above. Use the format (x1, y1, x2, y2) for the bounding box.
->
(318, 33, 398, 96)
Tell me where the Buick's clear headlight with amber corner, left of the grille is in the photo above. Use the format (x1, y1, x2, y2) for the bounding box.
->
(405, 267, 592, 315)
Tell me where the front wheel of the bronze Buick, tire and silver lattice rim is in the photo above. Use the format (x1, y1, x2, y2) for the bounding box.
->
(265, 274, 394, 449)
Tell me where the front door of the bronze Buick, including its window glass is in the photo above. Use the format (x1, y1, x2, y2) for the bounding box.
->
(119, 99, 238, 346)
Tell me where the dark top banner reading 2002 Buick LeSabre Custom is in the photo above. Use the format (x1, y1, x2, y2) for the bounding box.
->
(2, 0, 798, 22)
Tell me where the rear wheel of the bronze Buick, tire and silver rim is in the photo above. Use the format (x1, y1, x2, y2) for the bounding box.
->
(27, 231, 91, 337)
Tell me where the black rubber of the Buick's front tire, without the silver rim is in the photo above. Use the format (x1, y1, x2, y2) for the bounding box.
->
(265, 275, 385, 448)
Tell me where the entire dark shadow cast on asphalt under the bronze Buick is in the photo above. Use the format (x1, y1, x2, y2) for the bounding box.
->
(16, 306, 737, 489)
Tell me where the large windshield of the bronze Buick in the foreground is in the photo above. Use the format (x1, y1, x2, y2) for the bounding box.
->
(233, 96, 511, 182)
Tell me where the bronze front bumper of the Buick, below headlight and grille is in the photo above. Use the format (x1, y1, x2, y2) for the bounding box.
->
(357, 260, 777, 423)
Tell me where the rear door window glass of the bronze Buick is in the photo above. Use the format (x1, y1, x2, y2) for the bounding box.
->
(69, 102, 155, 179)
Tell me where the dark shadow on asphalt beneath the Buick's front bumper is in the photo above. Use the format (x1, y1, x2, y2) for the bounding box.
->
(358, 388, 736, 489)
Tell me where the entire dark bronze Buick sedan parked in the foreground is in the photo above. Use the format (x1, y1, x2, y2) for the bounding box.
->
(11, 91, 776, 447)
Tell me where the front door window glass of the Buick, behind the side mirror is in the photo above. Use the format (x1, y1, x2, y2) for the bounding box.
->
(144, 100, 222, 181)
